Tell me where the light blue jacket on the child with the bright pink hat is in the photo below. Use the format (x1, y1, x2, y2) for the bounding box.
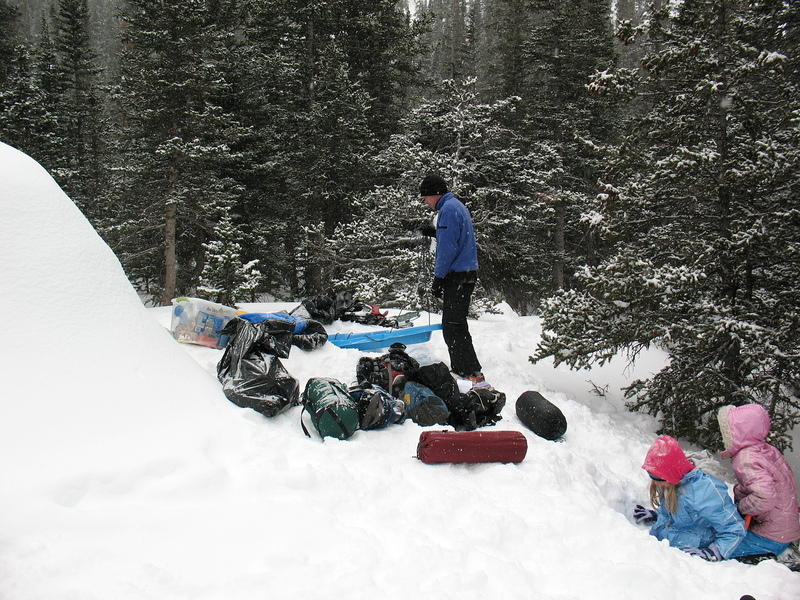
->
(650, 469, 746, 558)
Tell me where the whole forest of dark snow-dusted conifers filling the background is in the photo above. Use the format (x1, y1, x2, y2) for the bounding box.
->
(0, 0, 800, 446)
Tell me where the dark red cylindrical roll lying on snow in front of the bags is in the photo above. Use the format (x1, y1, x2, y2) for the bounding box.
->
(417, 431, 528, 465)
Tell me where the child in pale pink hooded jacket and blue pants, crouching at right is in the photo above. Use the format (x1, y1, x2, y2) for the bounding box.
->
(717, 404, 800, 557)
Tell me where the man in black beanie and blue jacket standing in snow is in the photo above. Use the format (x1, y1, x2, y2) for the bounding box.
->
(419, 175, 483, 383)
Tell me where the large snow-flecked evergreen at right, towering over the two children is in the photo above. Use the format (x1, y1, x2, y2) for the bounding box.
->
(535, 0, 800, 447)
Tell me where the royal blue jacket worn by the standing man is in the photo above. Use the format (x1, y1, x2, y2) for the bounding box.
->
(434, 192, 478, 277)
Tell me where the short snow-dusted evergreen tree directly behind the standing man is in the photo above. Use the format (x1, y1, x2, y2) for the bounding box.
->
(331, 79, 560, 310)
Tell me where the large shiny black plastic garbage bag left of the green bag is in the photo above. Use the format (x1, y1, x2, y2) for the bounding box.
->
(217, 318, 300, 417)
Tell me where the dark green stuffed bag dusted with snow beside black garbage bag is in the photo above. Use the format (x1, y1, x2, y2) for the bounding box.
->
(300, 377, 358, 440)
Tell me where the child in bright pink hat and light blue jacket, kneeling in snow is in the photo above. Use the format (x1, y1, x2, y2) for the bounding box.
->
(633, 435, 745, 561)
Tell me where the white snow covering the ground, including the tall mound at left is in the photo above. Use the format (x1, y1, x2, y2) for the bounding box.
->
(0, 144, 800, 600)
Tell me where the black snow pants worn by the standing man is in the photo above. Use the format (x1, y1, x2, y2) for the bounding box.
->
(442, 271, 481, 376)
